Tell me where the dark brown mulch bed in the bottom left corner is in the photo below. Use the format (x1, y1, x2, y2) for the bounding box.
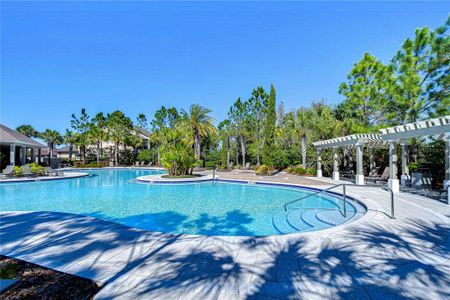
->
(0, 255, 99, 300)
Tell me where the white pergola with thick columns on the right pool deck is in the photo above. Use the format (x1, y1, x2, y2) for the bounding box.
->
(313, 116, 450, 192)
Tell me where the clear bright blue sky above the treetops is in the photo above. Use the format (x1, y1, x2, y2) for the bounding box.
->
(0, 2, 450, 131)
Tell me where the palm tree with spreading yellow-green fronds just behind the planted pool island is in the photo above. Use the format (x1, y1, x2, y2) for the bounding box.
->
(183, 104, 217, 159)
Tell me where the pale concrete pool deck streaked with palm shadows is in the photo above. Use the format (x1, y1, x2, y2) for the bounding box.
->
(0, 175, 450, 299)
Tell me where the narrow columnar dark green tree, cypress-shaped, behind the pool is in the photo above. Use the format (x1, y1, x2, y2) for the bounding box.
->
(263, 84, 277, 166)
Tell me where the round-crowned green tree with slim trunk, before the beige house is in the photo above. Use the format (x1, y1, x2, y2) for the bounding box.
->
(106, 110, 133, 166)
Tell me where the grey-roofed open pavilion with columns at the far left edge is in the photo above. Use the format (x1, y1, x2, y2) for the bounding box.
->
(0, 124, 46, 169)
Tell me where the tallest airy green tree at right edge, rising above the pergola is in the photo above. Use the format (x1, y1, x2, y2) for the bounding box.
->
(393, 22, 450, 123)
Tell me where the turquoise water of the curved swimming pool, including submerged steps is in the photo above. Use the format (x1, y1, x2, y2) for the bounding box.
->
(0, 169, 363, 236)
